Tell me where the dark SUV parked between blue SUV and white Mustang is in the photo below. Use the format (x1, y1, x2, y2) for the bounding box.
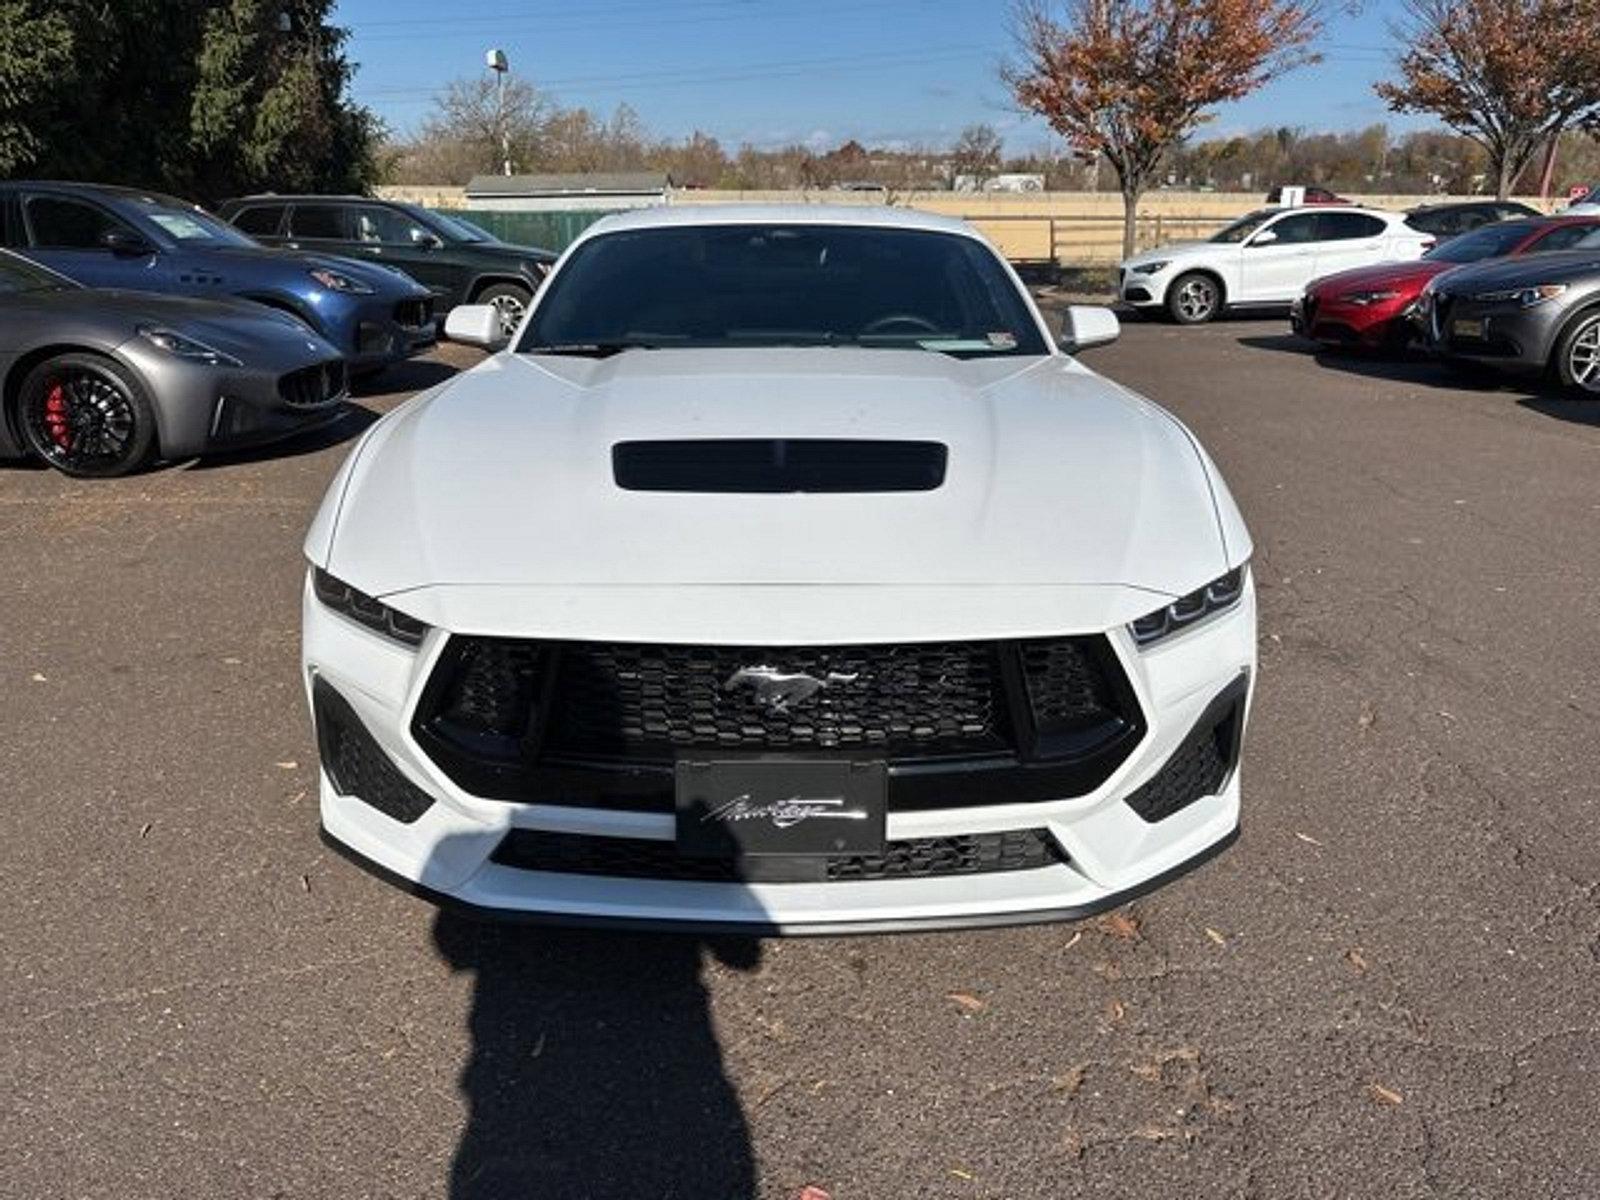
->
(221, 195, 557, 336)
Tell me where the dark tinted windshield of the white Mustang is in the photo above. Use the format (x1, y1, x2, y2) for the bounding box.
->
(517, 224, 1048, 357)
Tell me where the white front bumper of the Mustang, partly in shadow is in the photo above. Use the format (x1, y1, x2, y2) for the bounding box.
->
(304, 587, 1254, 934)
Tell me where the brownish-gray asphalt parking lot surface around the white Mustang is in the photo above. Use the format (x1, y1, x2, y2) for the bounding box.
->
(9, 320, 1600, 1200)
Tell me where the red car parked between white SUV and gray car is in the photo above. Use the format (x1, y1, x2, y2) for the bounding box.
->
(1290, 216, 1600, 349)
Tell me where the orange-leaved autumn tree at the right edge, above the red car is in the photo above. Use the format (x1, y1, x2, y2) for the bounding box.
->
(1376, 0, 1600, 200)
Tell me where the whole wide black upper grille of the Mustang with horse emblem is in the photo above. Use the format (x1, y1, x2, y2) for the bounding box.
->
(413, 637, 1144, 811)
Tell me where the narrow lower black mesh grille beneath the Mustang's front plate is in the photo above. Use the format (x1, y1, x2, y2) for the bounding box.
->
(494, 829, 1066, 883)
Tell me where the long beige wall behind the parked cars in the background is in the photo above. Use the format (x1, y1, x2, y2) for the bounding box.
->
(378, 187, 1557, 266)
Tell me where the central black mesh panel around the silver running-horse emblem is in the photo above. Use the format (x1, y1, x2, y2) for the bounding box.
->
(544, 642, 1008, 762)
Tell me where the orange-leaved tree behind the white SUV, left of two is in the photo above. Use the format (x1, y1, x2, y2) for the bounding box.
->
(1005, 0, 1322, 256)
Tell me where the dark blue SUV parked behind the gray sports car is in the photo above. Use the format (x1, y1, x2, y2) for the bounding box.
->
(0, 182, 437, 374)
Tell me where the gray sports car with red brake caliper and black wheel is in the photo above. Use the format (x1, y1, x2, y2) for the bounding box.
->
(0, 251, 346, 477)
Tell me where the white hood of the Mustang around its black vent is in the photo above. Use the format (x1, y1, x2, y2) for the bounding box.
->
(318, 349, 1228, 608)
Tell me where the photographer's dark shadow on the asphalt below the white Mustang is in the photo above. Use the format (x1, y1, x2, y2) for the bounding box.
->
(434, 914, 762, 1200)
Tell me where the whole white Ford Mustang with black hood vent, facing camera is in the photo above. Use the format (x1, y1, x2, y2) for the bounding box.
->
(304, 206, 1256, 933)
